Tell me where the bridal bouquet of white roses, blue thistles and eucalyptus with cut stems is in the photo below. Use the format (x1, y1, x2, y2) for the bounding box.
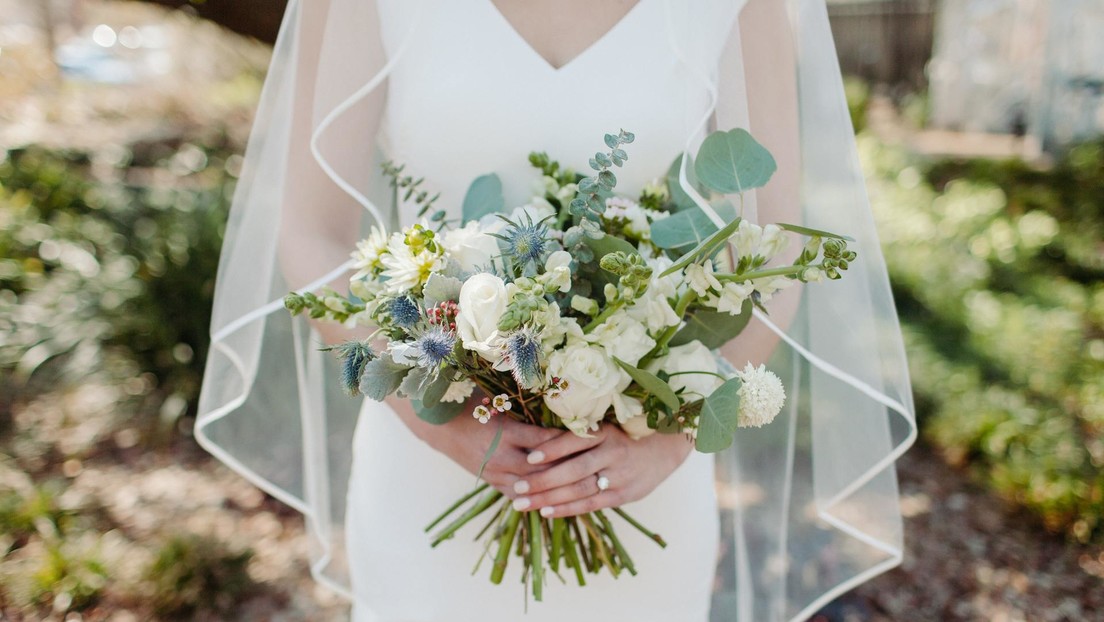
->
(285, 129, 856, 600)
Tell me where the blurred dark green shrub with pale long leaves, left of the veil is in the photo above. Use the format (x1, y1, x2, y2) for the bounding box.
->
(0, 137, 236, 426)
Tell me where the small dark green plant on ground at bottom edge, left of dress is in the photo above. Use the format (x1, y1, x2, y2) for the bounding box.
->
(146, 536, 257, 619)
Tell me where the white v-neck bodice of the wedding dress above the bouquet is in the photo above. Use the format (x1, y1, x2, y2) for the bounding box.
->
(379, 0, 709, 219)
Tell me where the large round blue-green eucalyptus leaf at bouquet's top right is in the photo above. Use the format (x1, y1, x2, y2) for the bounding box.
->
(694, 127, 777, 194)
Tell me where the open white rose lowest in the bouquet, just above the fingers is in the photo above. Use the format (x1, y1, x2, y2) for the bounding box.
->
(544, 344, 631, 436)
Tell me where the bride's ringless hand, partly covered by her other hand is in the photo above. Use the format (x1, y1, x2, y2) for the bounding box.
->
(388, 397, 574, 498)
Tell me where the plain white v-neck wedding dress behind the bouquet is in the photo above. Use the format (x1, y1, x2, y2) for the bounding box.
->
(346, 0, 719, 622)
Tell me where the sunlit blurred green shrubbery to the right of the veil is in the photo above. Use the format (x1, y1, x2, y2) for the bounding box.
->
(860, 137, 1104, 540)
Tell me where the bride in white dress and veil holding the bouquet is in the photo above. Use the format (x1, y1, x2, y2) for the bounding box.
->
(197, 0, 915, 622)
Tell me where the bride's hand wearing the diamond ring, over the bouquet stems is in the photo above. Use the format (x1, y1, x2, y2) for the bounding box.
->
(505, 425, 693, 517)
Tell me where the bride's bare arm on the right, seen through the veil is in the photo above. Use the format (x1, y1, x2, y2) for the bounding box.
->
(721, 0, 802, 366)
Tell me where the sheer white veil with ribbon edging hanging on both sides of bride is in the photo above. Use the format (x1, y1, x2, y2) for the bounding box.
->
(195, 0, 916, 622)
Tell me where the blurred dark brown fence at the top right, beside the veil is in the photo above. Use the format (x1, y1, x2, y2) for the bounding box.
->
(828, 0, 936, 89)
